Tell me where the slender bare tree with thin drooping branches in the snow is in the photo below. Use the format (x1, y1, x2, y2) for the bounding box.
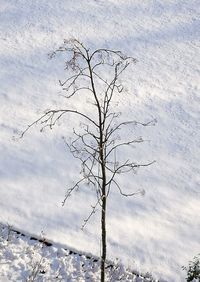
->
(22, 39, 154, 282)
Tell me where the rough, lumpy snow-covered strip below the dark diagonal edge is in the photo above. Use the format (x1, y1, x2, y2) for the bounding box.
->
(0, 226, 156, 282)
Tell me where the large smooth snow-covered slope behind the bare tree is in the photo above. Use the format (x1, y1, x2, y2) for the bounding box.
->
(0, 0, 200, 282)
